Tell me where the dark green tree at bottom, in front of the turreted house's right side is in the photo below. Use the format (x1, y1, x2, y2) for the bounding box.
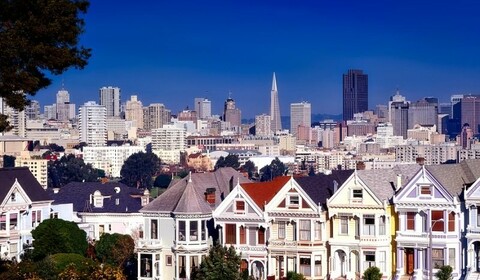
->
(191, 244, 241, 280)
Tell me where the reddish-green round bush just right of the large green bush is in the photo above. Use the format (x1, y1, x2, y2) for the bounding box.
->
(95, 233, 135, 267)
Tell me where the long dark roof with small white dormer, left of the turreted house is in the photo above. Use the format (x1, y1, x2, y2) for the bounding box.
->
(48, 182, 144, 213)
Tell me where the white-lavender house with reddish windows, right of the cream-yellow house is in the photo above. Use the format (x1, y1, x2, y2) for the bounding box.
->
(393, 164, 466, 279)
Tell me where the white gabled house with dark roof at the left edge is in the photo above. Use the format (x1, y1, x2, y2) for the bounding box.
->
(0, 167, 52, 260)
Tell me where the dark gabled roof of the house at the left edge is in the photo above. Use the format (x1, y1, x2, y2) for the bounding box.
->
(0, 167, 51, 202)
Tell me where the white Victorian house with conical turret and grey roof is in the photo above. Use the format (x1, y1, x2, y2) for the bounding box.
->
(136, 168, 249, 280)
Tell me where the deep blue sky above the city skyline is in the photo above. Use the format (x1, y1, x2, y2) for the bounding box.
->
(35, 0, 480, 118)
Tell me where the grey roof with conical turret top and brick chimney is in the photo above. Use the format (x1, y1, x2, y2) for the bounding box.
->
(141, 167, 250, 213)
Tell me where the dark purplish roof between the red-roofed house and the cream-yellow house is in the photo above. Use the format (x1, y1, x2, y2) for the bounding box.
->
(295, 170, 353, 205)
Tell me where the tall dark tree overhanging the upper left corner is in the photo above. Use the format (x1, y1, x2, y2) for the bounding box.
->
(0, 0, 90, 131)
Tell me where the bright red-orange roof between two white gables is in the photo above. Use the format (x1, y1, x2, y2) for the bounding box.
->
(240, 176, 291, 209)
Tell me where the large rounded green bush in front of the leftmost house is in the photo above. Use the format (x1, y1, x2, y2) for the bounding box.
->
(32, 219, 88, 260)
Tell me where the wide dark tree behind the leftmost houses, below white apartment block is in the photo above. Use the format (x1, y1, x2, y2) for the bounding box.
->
(48, 155, 99, 188)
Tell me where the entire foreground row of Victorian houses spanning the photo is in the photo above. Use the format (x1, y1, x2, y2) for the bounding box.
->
(0, 160, 480, 280)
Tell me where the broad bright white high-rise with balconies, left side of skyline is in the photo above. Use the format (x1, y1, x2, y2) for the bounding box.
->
(78, 101, 107, 147)
